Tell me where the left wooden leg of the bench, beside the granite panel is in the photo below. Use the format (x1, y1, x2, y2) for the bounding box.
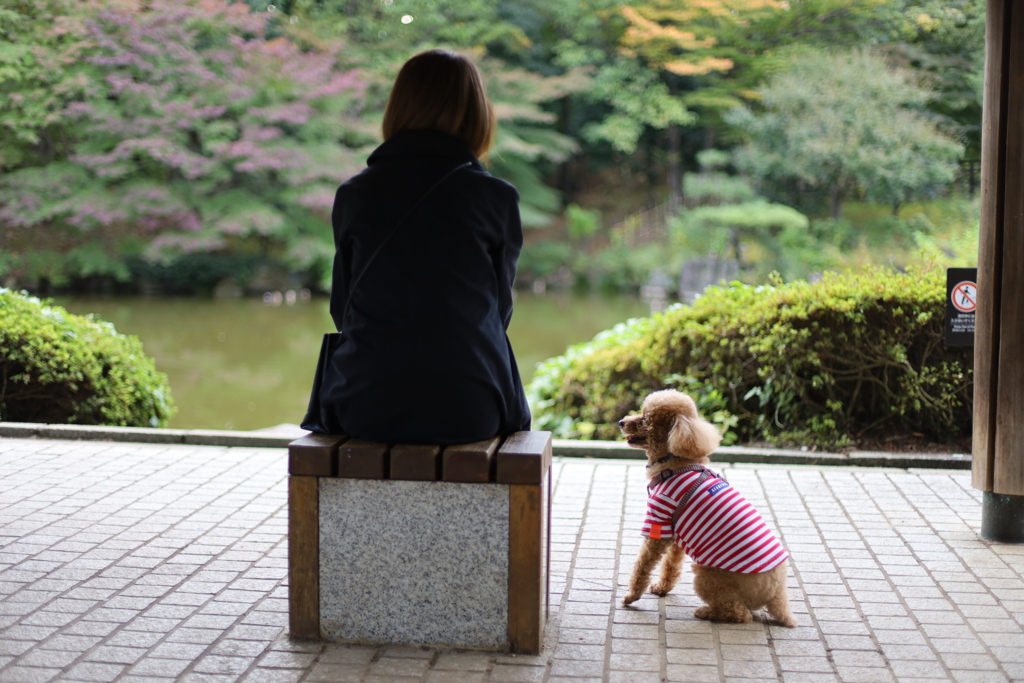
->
(288, 476, 319, 638)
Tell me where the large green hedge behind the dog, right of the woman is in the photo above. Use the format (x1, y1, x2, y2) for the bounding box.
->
(528, 268, 972, 447)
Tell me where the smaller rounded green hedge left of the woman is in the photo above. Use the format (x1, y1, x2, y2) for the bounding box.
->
(0, 289, 174, 427)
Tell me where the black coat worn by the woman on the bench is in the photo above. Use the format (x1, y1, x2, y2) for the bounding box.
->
(322, 131, 529, 443)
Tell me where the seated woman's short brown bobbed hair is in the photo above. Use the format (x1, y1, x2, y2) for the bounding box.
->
(383, 50, 498, 159)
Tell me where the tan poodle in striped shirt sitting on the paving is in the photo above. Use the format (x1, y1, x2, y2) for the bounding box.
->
(618, 389, 797, 627)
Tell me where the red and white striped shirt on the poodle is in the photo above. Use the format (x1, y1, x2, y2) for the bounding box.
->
(641, 468, 790, 573)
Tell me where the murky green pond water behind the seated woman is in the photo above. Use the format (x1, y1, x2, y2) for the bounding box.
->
(55, 293, 649, 430)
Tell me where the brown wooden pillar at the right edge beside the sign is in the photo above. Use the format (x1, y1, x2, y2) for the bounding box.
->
(972, 0, 1024, 543)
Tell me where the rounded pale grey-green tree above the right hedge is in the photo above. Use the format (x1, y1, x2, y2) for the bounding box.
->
(727, 51, 964, 218)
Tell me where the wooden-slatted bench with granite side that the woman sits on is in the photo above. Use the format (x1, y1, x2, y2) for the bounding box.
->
(288, 431, 551, 653)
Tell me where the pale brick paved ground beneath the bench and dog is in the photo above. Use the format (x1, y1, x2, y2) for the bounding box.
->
(0, 439, 1024, 683)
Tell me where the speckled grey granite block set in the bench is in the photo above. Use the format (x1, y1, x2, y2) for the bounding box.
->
(319, 478, 509, 650)
